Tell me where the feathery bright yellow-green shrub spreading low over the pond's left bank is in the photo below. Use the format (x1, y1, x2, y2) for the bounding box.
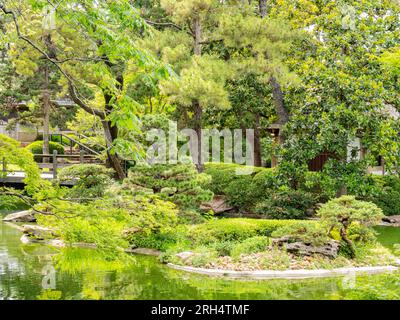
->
(37, 196, 177, 251)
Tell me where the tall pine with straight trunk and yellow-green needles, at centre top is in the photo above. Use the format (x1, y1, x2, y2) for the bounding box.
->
(148, 0, 230, 171)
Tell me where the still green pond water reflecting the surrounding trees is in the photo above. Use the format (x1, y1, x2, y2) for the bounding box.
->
(0, 215, 400, 299)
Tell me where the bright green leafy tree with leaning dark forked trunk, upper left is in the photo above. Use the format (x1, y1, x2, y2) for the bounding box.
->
(0, 0, 167, 178)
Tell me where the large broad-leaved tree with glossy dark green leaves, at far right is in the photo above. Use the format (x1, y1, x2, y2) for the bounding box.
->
(271, 0, 400, 190)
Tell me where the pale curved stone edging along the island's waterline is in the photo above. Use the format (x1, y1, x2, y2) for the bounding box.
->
(167, 263, 398, 279)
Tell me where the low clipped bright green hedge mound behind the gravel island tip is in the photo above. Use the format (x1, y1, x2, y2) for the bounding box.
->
(187, 218, 315, 244)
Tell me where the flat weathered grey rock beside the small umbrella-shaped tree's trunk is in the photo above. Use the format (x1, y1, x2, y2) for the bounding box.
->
(272, 236, 340, 258)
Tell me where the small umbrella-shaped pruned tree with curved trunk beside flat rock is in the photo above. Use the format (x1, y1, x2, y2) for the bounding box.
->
(318, 196, 383, 258)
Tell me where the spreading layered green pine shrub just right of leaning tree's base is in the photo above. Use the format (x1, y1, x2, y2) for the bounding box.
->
(123, 164, 213, 209)
